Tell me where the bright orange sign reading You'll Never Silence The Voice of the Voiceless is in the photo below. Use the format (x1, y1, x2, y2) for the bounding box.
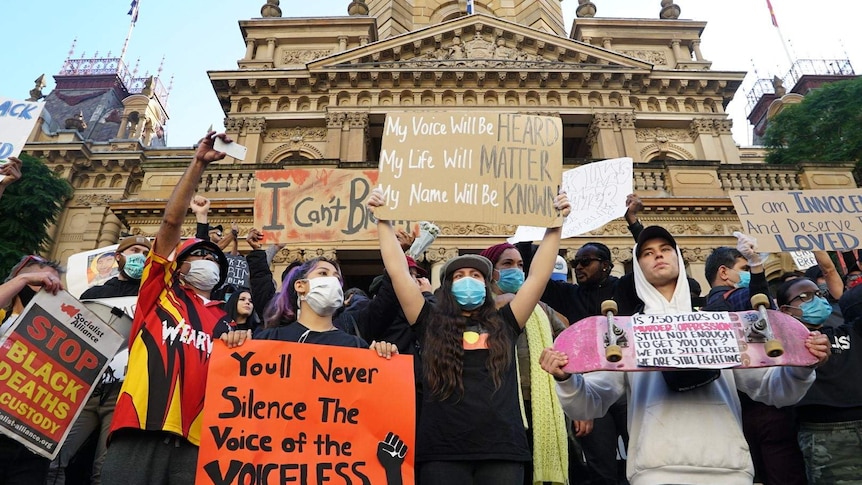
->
(195, 341, 416, 485)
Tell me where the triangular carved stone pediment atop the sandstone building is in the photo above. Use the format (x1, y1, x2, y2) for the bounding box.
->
(308, 14, 652, 72)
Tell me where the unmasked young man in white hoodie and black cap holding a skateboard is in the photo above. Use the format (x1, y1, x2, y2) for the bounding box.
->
(541, 226, 829, 485)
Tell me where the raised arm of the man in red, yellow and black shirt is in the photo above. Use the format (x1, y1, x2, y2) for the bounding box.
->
(153, 131, 230, 256)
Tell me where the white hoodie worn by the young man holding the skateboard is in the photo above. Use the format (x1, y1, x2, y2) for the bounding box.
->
(557, 248, 814, 485)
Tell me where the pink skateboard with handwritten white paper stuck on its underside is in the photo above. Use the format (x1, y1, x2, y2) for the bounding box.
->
(554, 295, 817, 374)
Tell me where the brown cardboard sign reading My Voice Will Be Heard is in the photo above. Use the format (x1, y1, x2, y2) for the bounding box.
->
(379, 111, 563, 227)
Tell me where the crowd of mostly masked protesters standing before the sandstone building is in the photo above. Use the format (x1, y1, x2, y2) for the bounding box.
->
(0, 127, 862, 485)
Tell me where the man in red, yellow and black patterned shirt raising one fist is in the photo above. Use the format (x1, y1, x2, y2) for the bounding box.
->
(102, 131, 251, 485)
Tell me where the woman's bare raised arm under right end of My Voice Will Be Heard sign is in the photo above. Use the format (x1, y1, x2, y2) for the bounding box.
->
(510, 194, 571, 327)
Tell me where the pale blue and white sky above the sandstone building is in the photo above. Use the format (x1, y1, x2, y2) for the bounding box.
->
(0, 0, 862, 147)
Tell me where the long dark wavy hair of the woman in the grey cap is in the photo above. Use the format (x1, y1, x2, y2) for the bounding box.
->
(422, 277, 513, 401)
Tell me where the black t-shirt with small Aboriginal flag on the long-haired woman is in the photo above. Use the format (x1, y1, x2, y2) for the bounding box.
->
(413, 301, 531, 462)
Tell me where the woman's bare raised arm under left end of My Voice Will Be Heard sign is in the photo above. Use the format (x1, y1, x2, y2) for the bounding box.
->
(368, 189, 426, 325)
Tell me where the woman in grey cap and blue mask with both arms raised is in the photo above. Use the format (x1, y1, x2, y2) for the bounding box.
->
(368, 189, 569, 485)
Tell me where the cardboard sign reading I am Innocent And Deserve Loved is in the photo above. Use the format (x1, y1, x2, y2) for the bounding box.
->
(729, 189, 862, 253)
